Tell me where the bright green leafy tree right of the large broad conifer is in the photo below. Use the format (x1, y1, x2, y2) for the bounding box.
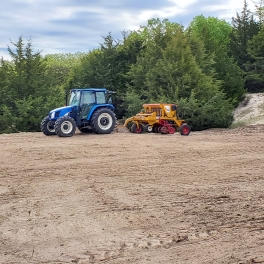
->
(187, 15, 245, 103)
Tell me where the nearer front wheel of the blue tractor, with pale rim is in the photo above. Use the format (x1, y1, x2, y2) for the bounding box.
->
(55, 116, 76, 137)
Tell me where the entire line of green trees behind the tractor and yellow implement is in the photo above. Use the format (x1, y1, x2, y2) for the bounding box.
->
(0, 0, 264, 133)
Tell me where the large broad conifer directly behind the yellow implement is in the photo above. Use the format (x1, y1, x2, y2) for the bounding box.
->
(121, 18, 233, 130)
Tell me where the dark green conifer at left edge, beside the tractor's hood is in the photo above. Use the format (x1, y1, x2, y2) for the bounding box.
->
(0, 37, 63, 132)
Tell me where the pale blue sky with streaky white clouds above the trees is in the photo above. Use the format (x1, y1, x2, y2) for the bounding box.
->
(0, 0, 255, 59)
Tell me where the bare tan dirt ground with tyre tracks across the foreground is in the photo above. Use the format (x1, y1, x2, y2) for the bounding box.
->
(0, 125, 264, 264)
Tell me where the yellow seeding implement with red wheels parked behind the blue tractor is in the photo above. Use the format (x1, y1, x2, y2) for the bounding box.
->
(124, 104, 191, 136)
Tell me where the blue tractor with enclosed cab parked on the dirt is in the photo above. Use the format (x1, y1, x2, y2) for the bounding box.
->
(41, 88, 116, 137)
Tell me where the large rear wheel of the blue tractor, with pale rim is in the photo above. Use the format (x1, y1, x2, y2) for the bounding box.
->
(91, 108, 116, 134)
